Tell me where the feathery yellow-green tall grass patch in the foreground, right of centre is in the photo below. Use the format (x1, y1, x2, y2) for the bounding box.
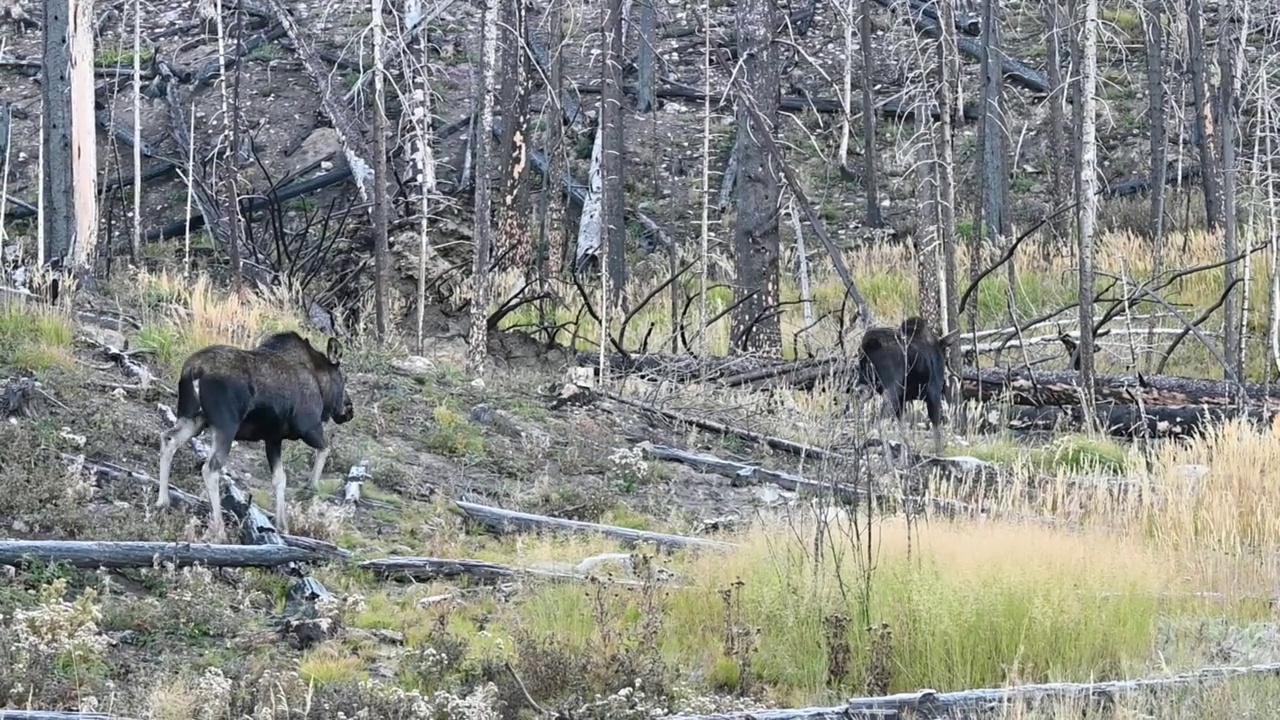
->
(491, 509, 1259, 702)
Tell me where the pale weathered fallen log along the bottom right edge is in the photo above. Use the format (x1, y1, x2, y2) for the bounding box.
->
(671, 662, 1280, 720)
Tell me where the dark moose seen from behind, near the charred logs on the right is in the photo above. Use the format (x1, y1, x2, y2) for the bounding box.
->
(855, 316, 957, 455)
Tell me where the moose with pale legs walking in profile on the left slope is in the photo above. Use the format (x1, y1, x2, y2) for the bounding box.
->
(156, 331, 356, 541)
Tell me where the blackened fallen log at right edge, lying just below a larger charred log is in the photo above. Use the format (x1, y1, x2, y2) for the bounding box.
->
(1005, 404, 1280, 438)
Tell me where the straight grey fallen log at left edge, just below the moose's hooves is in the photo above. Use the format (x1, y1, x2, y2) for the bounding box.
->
(0, 539, 329, 570)
